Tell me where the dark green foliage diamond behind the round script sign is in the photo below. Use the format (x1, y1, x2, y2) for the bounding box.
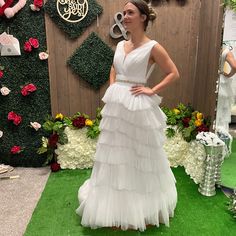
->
(45, 0, 103, 38)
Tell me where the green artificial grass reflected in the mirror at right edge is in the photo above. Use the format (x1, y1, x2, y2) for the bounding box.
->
(221, 139, 236, 189)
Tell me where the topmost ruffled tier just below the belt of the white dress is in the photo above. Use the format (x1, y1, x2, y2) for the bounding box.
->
(102, 83, 161, 111)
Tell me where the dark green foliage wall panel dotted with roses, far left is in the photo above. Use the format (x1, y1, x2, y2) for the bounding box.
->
(0, 0, 51, 167)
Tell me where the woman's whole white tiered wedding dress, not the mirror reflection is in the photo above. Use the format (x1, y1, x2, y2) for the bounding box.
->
(76, 40, 177, 231)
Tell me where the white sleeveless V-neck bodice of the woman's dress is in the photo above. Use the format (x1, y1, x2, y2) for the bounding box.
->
(113, 40, 157, 83)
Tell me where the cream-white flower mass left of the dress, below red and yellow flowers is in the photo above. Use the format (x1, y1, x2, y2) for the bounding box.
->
(55, 127, 97, 169)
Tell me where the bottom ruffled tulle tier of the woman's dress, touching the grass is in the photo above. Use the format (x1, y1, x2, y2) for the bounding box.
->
(76, 180, 177, 231)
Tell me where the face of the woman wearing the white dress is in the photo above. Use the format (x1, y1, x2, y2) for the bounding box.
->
(123, 2, 146, 32)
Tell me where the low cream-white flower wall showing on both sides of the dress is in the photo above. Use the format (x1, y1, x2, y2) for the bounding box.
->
(55, 127, 210, 184)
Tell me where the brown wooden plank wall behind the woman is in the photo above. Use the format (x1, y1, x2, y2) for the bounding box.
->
(46, 0, 222, 117)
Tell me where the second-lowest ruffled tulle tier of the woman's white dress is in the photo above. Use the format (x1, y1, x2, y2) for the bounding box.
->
(88, 161, 175, 194)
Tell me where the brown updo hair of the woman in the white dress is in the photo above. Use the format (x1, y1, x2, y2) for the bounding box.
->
(126, 0, 156, 31)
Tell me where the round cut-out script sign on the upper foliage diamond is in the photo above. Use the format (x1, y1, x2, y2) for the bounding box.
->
(57, 0, 88, 23)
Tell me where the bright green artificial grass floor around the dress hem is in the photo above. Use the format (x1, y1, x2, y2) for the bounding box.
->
(25, 167, 236, 236)
